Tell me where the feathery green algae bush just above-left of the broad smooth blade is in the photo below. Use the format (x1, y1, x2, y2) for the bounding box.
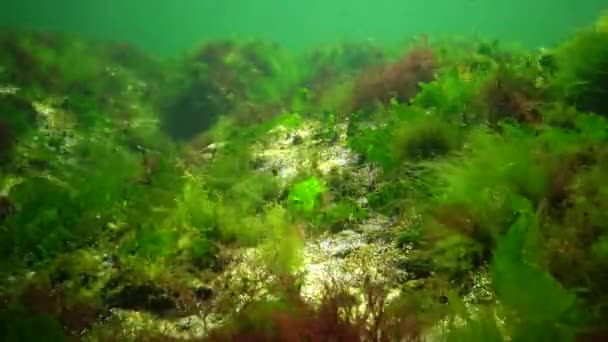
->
(432, 126, 549, 257)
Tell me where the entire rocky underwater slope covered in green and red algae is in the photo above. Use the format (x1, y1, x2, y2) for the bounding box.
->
(0, 10, 608, 341)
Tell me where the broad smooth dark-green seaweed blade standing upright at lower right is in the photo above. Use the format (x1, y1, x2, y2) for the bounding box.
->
(492, 201, 576, 341)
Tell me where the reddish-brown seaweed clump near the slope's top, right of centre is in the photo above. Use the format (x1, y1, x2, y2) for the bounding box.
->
(353, 47, 437, 110)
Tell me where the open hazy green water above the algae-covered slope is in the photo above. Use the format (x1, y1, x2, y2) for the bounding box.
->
(0, 0, 606, 54)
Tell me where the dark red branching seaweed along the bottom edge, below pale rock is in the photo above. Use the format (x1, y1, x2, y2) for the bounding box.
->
(207, 284, 421, 342)
